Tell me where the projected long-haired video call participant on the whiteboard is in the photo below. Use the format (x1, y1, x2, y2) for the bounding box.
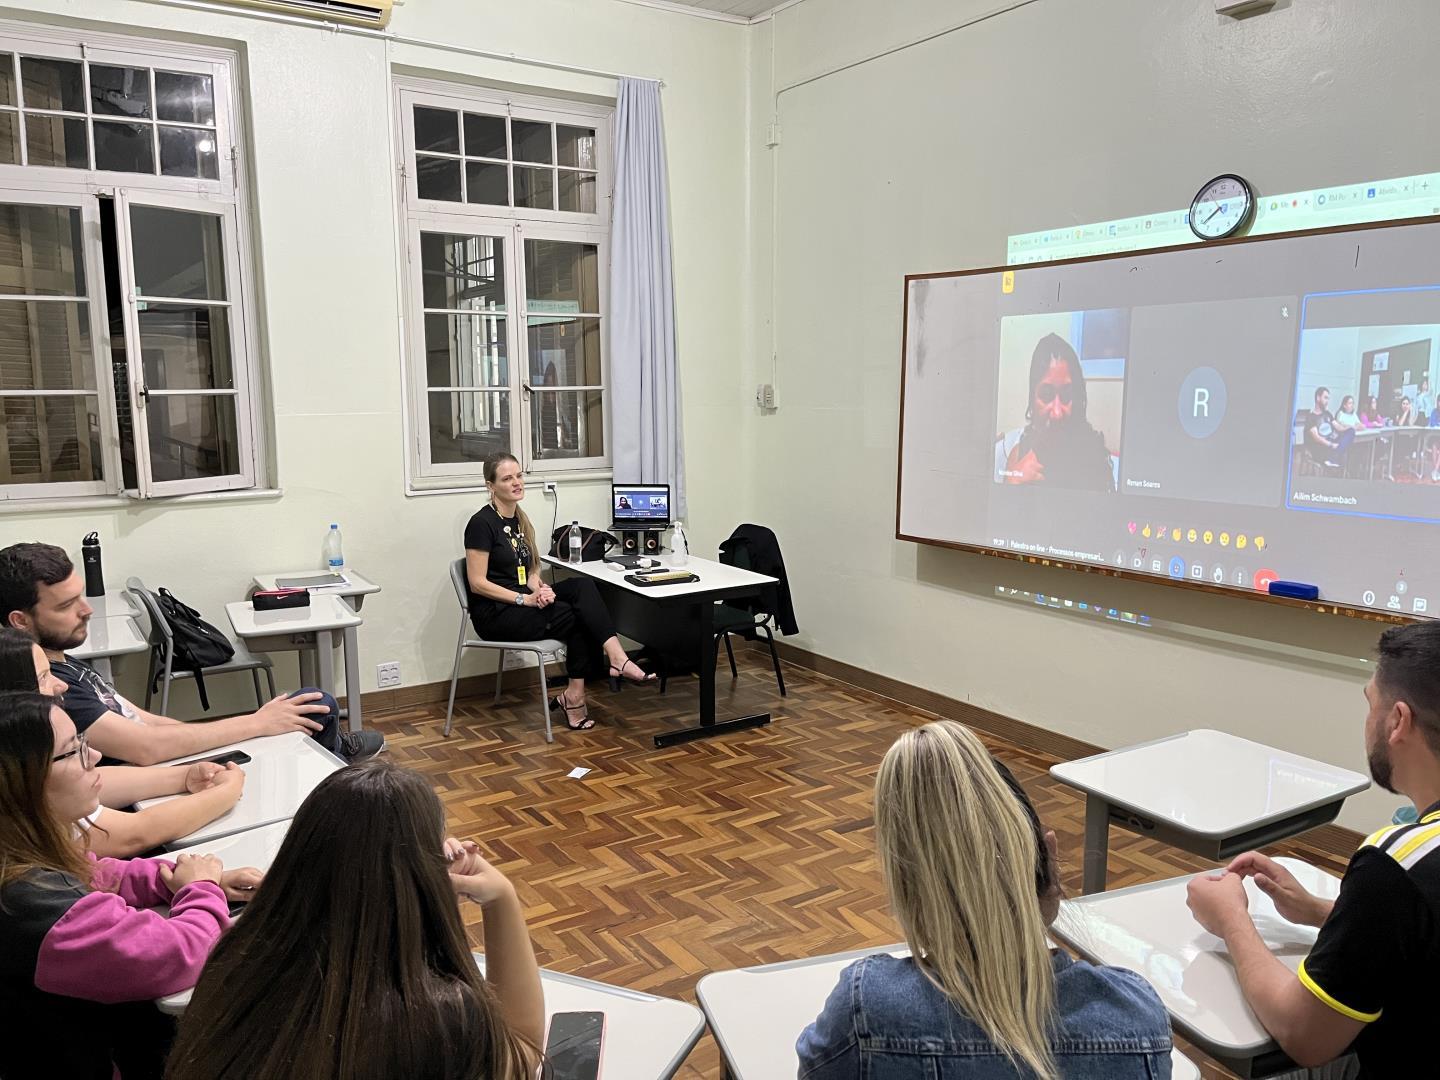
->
(995, 334, 1115, 491)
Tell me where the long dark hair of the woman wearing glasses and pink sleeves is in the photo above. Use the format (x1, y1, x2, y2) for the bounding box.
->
(0, 696, 89, 886)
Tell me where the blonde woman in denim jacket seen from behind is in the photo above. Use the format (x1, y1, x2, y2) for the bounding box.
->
(796, 720, 1171, 1080)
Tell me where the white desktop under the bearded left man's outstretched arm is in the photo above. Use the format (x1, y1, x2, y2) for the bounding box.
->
(135, 732, 344, 851)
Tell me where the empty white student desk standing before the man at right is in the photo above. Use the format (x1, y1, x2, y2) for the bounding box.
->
(1050, 729, 1369, 893)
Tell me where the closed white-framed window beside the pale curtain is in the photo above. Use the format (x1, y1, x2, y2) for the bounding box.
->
(396, 79, 613, 490)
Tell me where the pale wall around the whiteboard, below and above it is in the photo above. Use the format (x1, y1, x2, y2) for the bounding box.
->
(750, 0, 1440, 829)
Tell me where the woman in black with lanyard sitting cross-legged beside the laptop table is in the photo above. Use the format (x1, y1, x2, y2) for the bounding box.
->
(465, 454, 657, 732)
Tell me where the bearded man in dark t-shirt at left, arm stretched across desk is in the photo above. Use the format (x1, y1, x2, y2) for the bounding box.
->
(0, 544, 384, 765)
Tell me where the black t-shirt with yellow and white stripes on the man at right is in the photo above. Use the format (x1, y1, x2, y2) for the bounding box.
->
(1300, 804, 1440, 1080)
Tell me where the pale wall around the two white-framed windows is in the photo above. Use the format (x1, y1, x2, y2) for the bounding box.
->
(8, 0, 746, 714)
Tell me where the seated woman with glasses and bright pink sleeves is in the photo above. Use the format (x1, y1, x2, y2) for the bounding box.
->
(0, 694, 253, 1080)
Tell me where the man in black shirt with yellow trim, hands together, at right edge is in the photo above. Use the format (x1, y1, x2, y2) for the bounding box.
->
(1189, 621, 1440, 1079)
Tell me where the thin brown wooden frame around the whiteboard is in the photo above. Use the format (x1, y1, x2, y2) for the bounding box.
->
(896, 215, 1440, 624)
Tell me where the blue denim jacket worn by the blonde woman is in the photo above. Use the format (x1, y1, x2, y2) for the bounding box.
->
(795, 952, 1171, 1080)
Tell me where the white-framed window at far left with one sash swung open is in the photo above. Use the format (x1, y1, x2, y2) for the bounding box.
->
(0, 24, 258, 501)
